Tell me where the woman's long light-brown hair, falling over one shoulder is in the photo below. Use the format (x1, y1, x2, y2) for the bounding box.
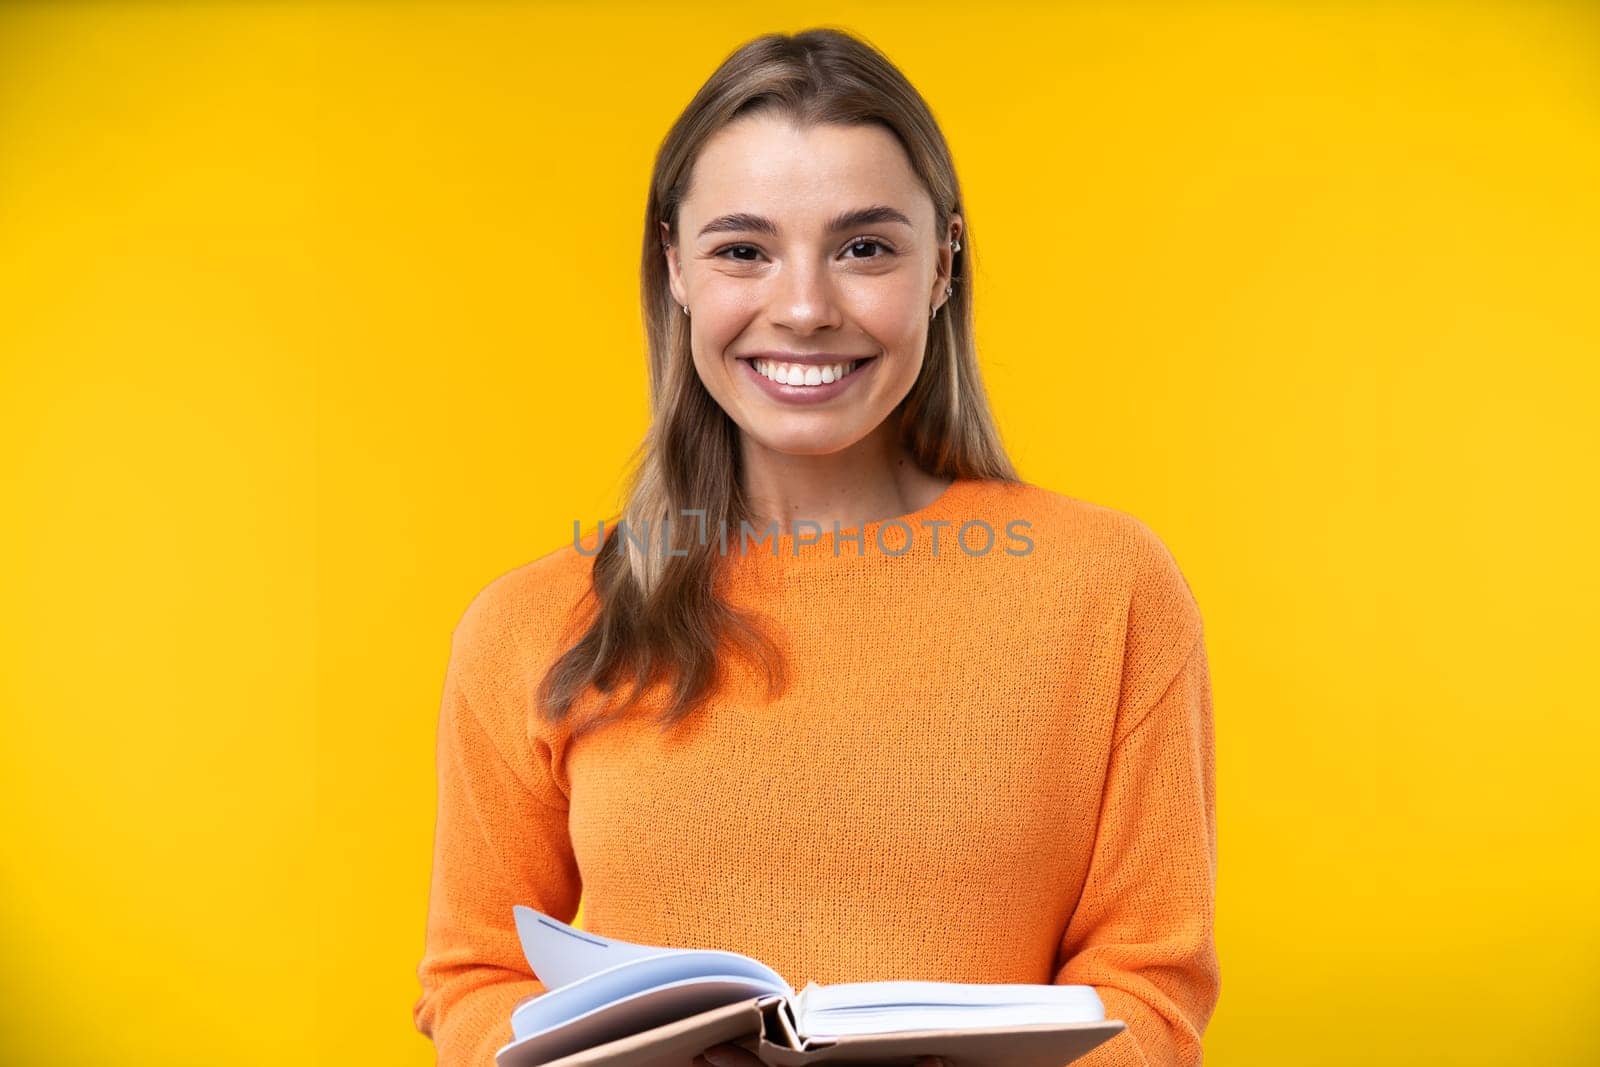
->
(534, 27, 1018, 736)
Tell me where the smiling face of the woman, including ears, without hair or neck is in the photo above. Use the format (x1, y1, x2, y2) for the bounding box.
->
(662, 115, 962, 454)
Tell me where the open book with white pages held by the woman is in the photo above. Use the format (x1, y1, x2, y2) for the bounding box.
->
(494, 905, 1123, 1067)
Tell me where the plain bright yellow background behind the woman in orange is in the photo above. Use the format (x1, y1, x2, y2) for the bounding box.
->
(0, 3, 1600, 1065)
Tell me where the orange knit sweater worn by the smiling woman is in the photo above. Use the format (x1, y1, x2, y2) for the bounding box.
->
(413, 480, 1219, 1067)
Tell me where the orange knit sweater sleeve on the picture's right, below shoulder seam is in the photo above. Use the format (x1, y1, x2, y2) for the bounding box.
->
(1054, 635, 1221, 1067)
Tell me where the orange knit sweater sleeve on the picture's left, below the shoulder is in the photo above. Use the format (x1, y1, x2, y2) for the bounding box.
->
(411, 601, 581, 1067)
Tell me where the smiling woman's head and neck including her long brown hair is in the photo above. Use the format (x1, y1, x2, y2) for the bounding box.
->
(541, 29, 1019, 742)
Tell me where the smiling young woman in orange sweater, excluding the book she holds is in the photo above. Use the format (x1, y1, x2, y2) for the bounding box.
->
(414, 29, 1219, 1067)
